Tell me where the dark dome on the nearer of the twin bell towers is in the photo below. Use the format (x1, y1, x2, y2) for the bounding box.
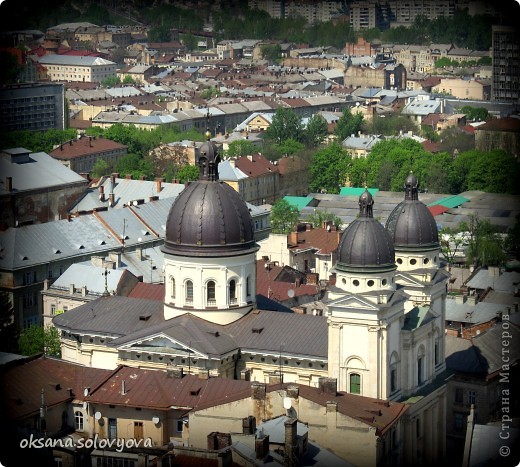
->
(336, 190, 395, 271)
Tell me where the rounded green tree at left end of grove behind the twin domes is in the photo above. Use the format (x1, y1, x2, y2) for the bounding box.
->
(309, 143, 351, 193)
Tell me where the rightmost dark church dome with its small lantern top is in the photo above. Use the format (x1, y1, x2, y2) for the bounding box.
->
(386, 174, 439, 248)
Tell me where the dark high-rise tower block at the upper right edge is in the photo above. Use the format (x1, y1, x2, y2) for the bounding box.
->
(491, 25, 520, 104)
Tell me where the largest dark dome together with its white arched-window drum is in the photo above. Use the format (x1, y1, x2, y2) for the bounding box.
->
(162, 132, 258, 324)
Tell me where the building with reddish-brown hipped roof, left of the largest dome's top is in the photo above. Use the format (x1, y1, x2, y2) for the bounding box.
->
(49, 136, 128, 173)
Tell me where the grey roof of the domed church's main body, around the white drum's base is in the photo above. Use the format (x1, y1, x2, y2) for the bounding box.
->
(53, 296, 327, 362)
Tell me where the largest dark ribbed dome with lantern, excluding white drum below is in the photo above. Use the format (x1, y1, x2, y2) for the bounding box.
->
(162, 135, 255, 257)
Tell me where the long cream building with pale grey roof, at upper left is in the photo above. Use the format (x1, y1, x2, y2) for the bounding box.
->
(38, 55, 117, 83)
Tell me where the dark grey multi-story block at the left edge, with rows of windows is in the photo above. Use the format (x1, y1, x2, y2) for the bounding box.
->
(0, 83, 66, 131)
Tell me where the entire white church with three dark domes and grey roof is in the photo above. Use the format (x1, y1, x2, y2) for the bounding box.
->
(53, 141, 447, 465)
